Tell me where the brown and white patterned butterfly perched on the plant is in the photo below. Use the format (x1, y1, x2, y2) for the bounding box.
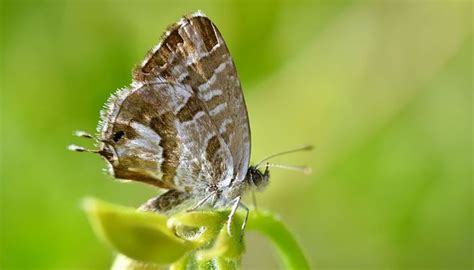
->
(70, 11, 309, 233)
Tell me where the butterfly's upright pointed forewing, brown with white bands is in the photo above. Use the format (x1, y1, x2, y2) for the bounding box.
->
(133, 12, 250, 185)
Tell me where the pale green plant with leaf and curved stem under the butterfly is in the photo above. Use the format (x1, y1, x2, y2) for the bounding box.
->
(84, 199, 309, 270)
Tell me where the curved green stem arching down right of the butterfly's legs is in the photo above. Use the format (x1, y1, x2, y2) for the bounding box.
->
(244, 210, 310, 270)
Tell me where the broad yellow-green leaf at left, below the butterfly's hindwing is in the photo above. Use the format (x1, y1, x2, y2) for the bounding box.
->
(84, 199, 195, 264)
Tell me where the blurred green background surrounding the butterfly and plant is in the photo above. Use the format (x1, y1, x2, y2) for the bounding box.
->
(0, 0, 474, 269)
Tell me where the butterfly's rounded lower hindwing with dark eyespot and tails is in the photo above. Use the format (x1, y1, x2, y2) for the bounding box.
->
(100, 82, 233, 191)
